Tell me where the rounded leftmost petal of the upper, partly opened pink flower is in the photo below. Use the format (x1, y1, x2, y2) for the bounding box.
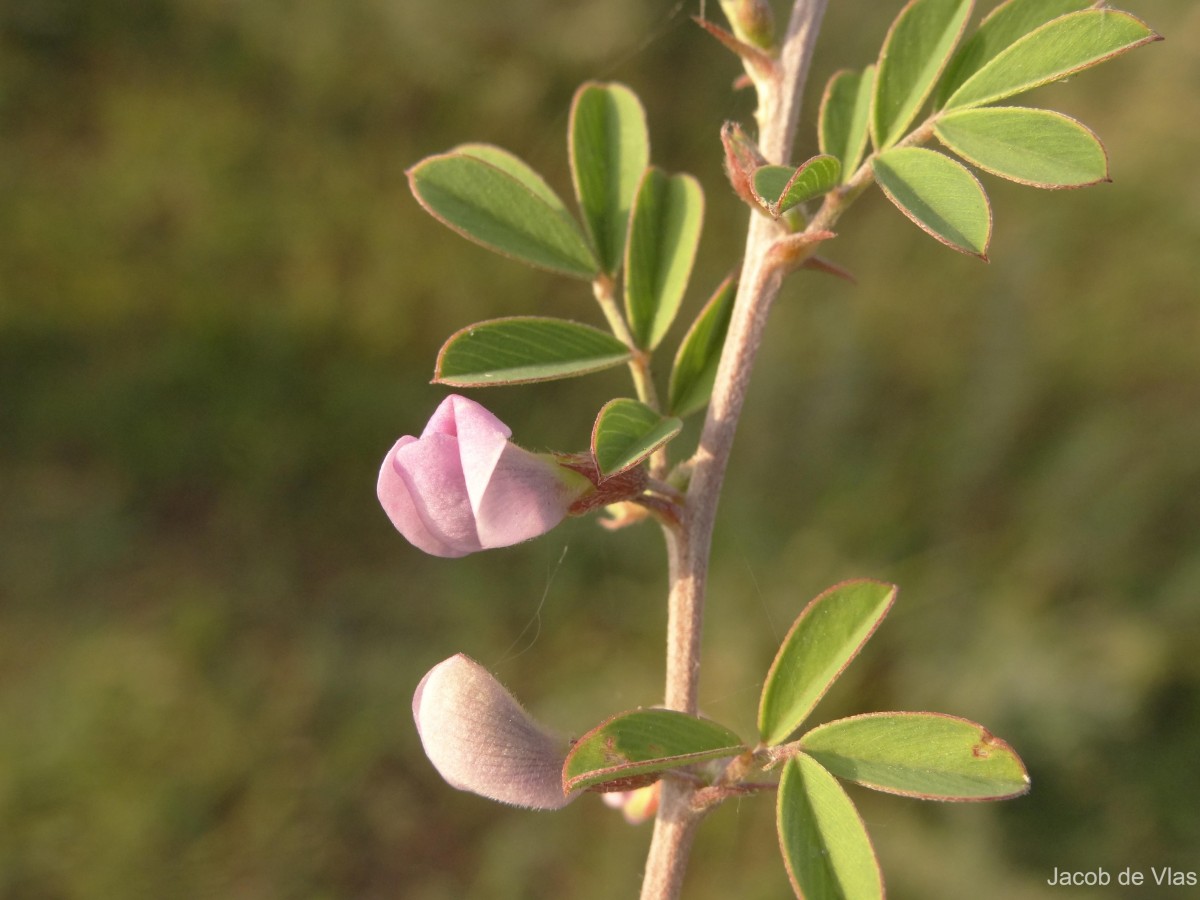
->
(377, 434, 482, 557)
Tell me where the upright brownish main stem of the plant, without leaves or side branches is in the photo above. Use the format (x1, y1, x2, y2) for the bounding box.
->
(641, 0, 827, 900)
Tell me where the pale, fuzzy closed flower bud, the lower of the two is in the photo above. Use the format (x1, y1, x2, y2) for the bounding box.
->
(413, 653, 578, 809)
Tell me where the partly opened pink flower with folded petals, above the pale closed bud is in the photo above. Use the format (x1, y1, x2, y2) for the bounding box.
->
(378, 394, 593, 557)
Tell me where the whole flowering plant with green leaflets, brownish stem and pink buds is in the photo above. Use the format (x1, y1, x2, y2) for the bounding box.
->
(379, 0, 1158, 900)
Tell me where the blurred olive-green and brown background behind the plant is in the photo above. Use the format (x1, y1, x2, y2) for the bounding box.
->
(0, 0, 1200, 900)
